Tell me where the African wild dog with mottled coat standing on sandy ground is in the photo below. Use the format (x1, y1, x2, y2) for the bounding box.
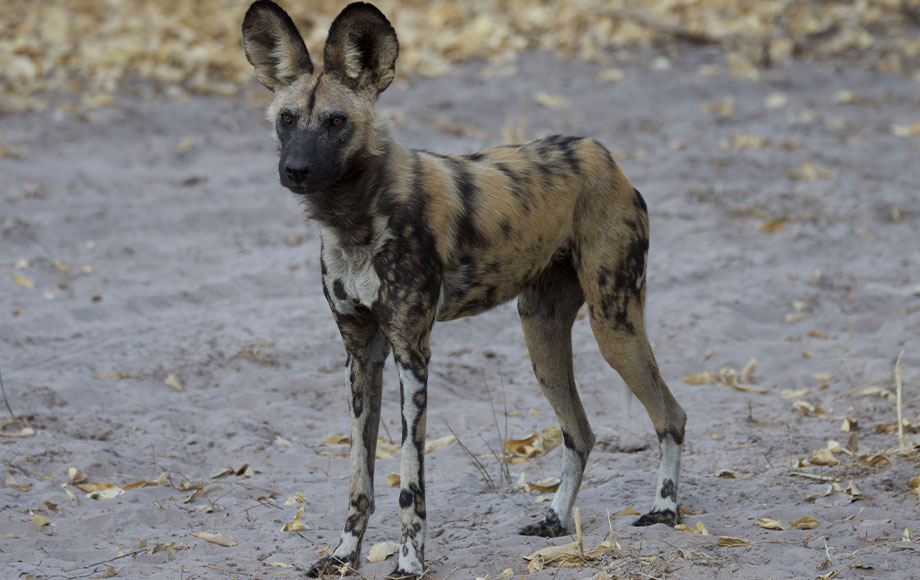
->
(243, 0, 686, 578)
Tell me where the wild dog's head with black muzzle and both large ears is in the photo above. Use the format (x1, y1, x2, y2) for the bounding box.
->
(243, 0, 399, 194)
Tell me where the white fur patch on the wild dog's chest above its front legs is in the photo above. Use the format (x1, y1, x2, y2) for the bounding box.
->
(322, 231, 380, 308)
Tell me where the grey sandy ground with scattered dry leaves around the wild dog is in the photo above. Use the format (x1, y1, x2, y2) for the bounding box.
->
(0, 49, 920, 580)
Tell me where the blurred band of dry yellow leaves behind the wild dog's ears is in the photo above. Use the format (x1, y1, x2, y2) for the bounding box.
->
(0, 0, 920, 113)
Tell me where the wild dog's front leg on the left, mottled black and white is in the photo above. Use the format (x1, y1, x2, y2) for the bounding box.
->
(307, 284, 390, 578)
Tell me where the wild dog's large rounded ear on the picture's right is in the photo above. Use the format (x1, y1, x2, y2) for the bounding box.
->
(323, 2, 399, 97)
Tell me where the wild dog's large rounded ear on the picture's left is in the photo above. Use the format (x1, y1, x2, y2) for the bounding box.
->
(243, 0, 313, 91)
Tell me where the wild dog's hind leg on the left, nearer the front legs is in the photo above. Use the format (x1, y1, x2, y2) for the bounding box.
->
(518, 262, 594, 537)
